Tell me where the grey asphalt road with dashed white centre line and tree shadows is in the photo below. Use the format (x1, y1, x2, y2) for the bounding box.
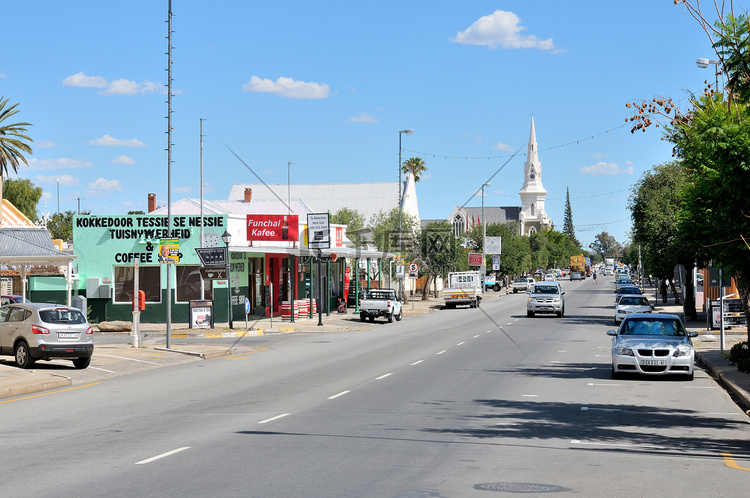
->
(0, 279, 750, 497)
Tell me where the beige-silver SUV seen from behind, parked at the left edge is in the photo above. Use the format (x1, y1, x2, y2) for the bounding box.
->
(0, 303, 94, 368)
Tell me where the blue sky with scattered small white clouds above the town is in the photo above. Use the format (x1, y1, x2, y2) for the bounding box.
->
(0, 0, 728, 245)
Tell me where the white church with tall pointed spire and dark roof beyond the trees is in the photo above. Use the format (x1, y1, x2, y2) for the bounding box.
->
(448, 116, 552, 236)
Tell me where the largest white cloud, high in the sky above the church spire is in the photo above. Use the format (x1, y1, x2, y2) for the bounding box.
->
(450, 9, 564, 52)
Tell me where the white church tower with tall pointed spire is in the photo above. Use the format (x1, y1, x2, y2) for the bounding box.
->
(518, 116, 551, 235)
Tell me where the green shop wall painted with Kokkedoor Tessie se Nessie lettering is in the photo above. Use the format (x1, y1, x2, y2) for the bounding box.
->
(73, 215, 232, 323)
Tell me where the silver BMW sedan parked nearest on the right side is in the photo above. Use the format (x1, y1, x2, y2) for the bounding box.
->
(607, 313, 698, 380)
